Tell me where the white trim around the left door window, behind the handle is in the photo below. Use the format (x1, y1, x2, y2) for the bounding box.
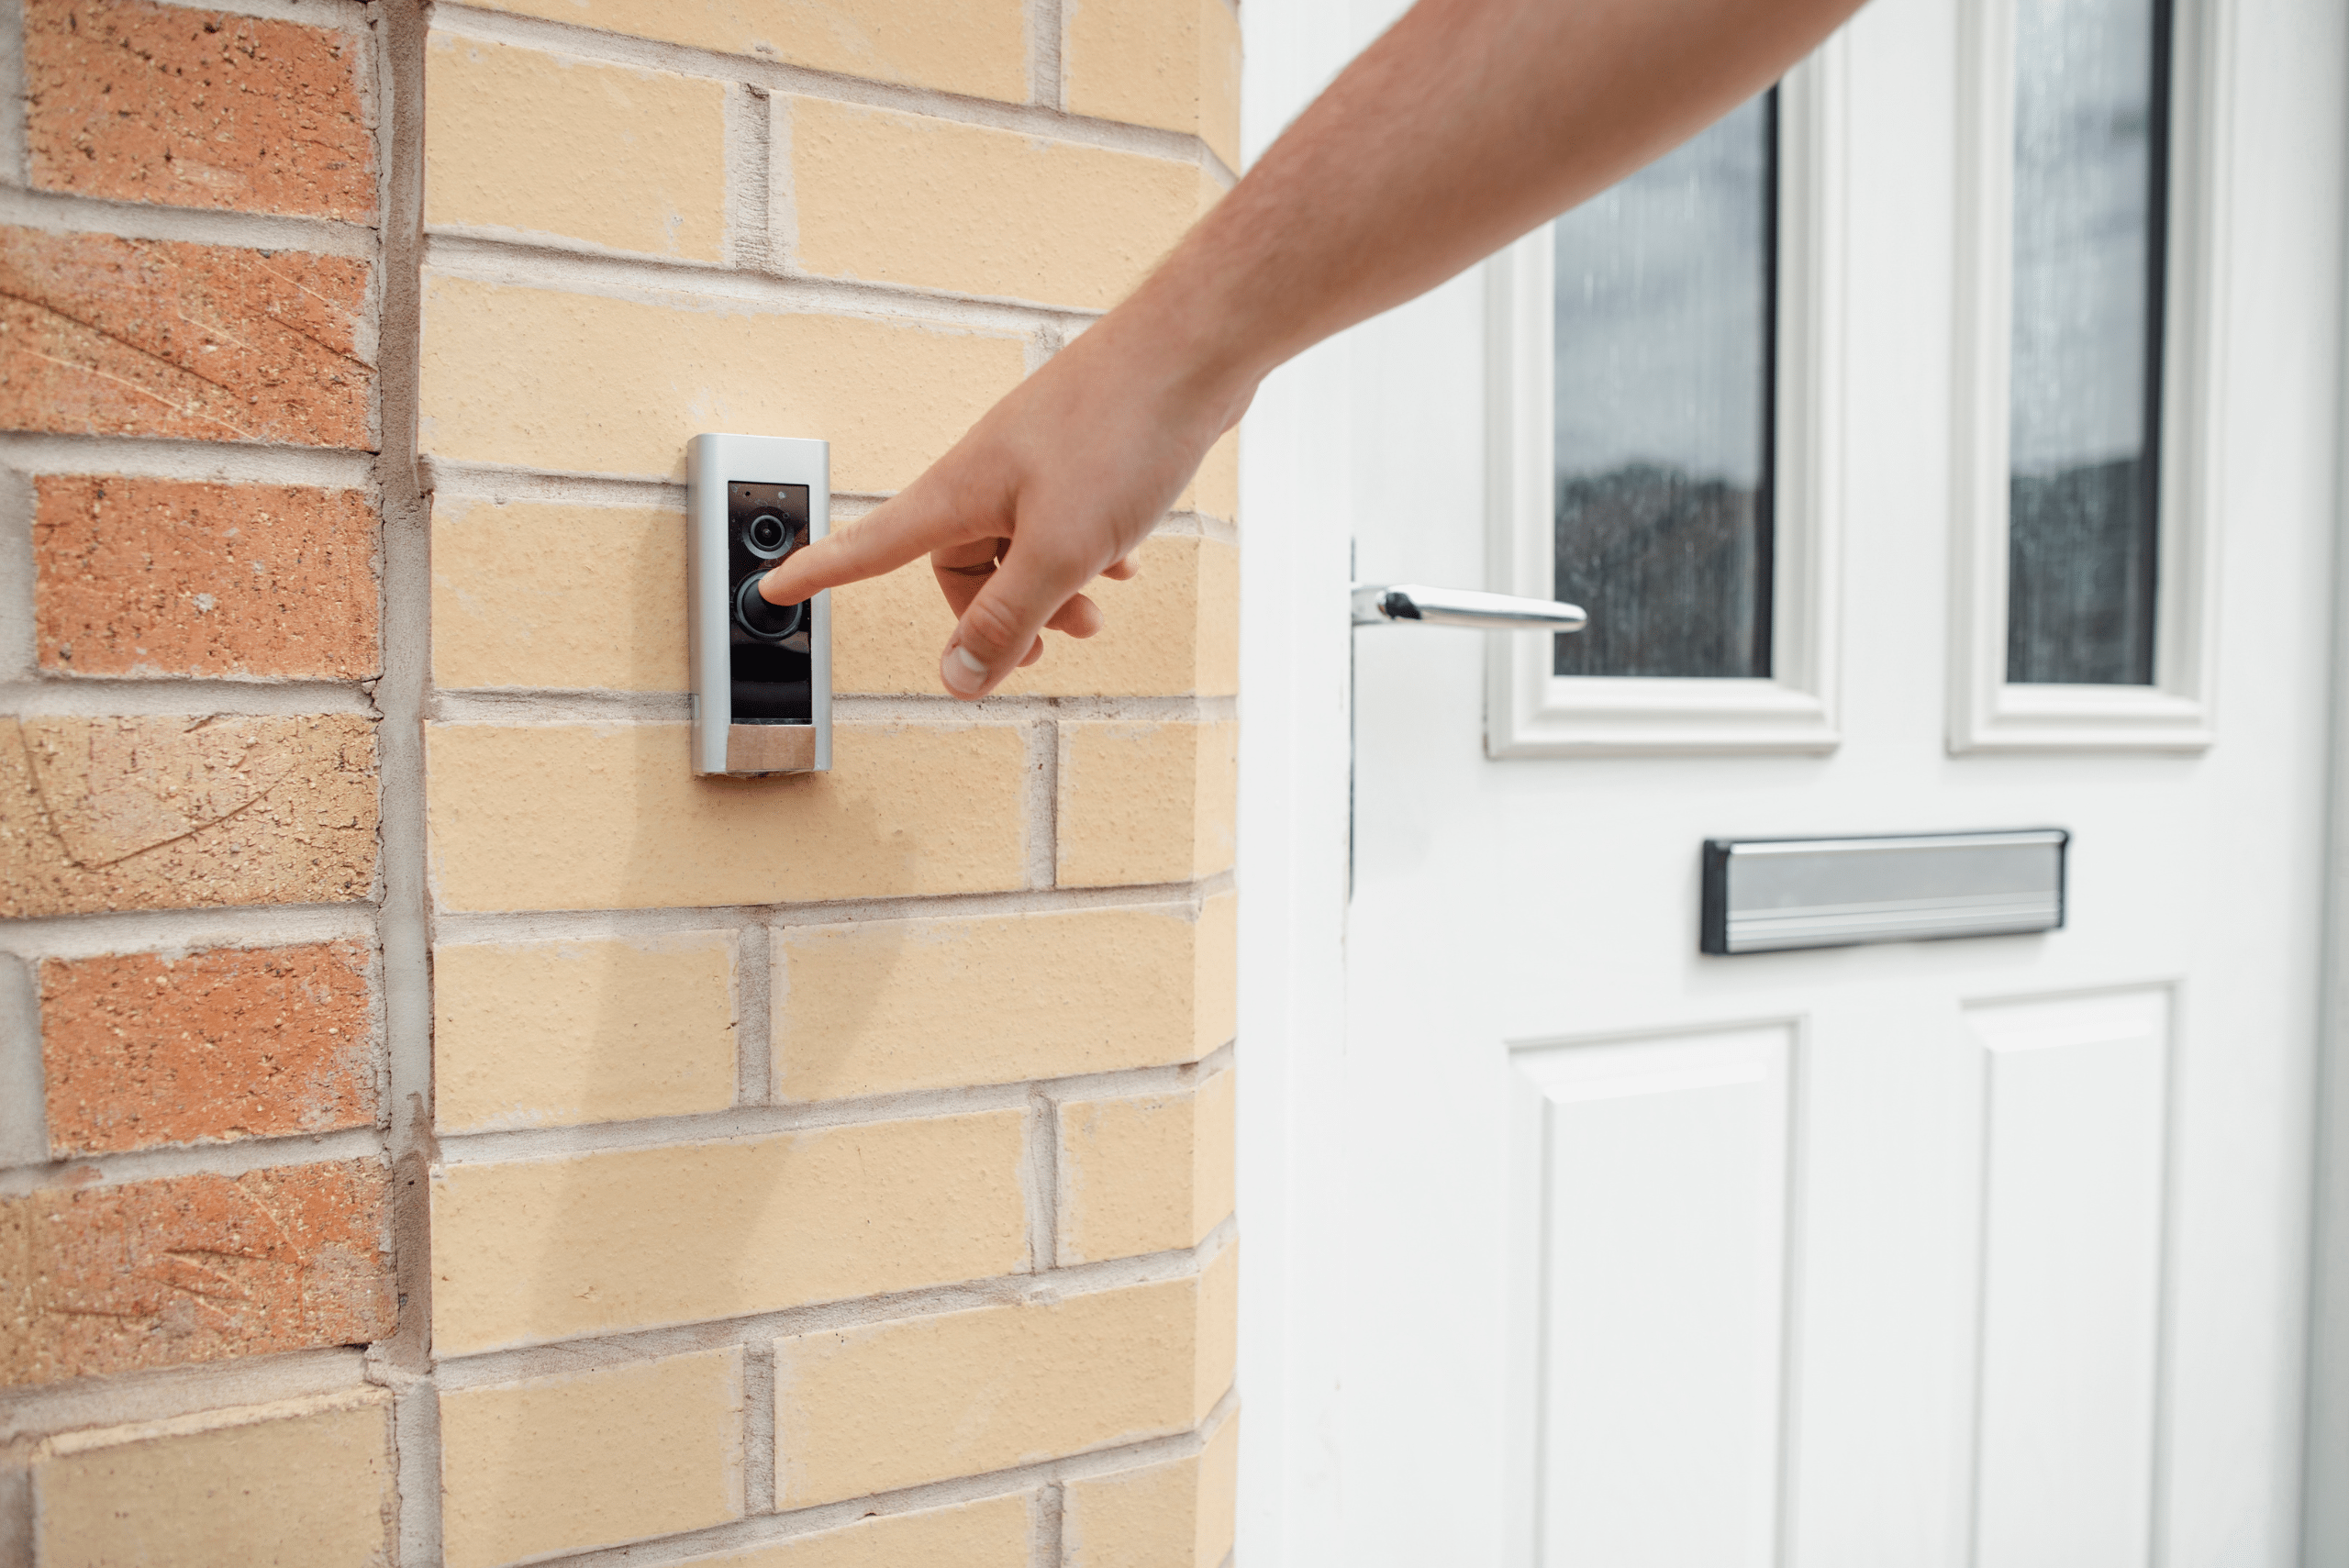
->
(1485, 35, 1846, 758)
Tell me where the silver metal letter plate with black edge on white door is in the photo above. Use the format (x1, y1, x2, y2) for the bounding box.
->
(1698, 828, 2072, 953)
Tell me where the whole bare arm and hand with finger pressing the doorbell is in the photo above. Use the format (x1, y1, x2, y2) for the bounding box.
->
(759, 0, 1861, 697)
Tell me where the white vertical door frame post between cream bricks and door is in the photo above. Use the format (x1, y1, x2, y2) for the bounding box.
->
(1236, 0, 1355, 1568)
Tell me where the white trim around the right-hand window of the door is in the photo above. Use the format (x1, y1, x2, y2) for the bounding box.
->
(1950, 0, 2232, 751)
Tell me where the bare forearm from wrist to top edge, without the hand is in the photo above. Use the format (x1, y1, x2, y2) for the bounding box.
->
(1118, 0, 1858, 423)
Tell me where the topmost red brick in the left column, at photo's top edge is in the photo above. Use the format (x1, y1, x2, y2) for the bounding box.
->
(24, 0, 376, 223)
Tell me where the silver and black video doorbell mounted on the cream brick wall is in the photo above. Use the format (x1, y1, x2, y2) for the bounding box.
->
(686, 434, 831, 774)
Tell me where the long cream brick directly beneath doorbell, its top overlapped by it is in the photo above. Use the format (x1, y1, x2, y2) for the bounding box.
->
(428, 723, 1029, 908)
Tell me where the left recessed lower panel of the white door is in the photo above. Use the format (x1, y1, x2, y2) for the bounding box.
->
(1515, 1026, 1792, 1568)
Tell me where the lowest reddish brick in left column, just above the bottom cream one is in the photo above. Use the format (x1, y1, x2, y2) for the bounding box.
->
(0, 1160, 397, 1385)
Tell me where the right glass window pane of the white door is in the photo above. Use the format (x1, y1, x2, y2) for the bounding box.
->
(2006, 0, 2168, 685)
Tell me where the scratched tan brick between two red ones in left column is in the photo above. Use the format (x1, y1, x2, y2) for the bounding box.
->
(0, 714, 376, 917)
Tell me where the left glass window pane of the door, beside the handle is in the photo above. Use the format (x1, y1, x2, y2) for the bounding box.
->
(1553, 92, 1778, 676)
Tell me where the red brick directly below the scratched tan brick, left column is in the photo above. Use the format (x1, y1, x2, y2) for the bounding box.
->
(40, 941, 376, 1160)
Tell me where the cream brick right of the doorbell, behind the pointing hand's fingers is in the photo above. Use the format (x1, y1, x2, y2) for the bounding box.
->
(831, 535, 1241, 697)
